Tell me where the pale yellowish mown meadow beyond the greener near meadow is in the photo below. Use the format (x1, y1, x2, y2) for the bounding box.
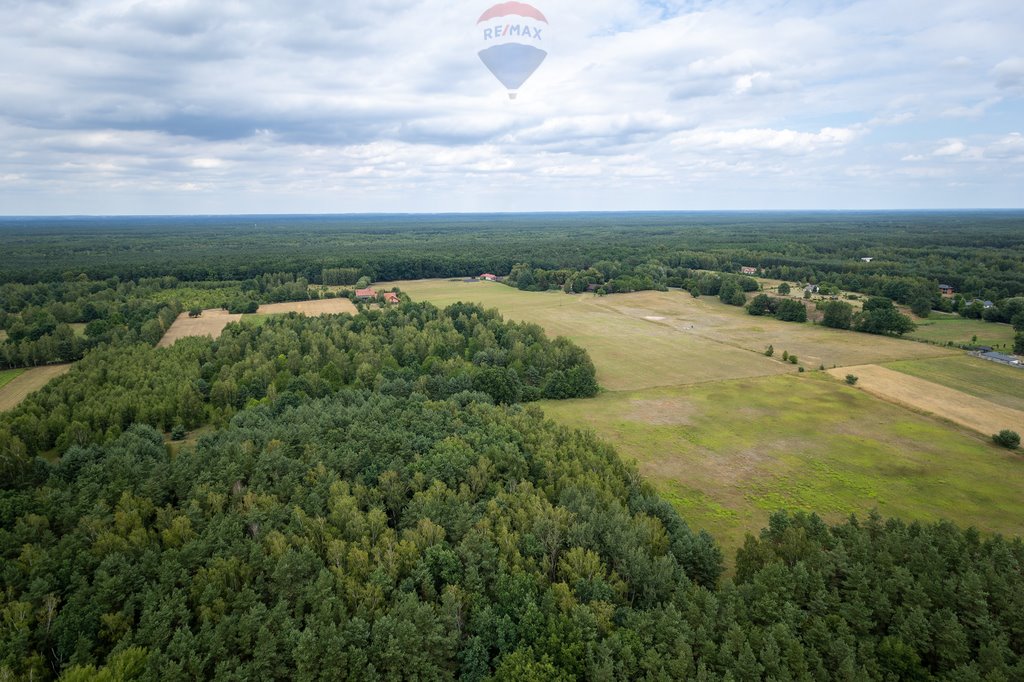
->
(398, 280, 950, 390)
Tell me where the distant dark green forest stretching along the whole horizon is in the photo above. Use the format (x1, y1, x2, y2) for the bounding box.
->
(0, 211, 1024, 303)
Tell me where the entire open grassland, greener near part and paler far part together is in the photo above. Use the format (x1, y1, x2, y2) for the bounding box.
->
(399, 281, 1024, 555)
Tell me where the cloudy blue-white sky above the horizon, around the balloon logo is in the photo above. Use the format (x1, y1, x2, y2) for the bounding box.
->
(0, 0, 1024, 215)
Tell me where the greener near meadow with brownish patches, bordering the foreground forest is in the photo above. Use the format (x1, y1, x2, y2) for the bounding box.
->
(544, 373, 1024, 554)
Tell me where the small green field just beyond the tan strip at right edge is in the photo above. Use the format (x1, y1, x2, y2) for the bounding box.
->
(885, 355, 1024, 410)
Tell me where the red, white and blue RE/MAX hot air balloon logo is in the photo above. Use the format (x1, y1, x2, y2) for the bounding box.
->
(476, 2, 548, 99)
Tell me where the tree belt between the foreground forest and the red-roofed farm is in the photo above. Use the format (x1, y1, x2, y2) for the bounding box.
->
(0, 303, 598, 466)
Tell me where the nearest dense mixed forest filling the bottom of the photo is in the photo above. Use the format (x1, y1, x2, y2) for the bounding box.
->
(0, 389, 1024, 682)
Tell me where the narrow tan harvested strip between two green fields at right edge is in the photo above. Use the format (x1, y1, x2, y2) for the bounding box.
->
(829, 365, 1024, 435)
